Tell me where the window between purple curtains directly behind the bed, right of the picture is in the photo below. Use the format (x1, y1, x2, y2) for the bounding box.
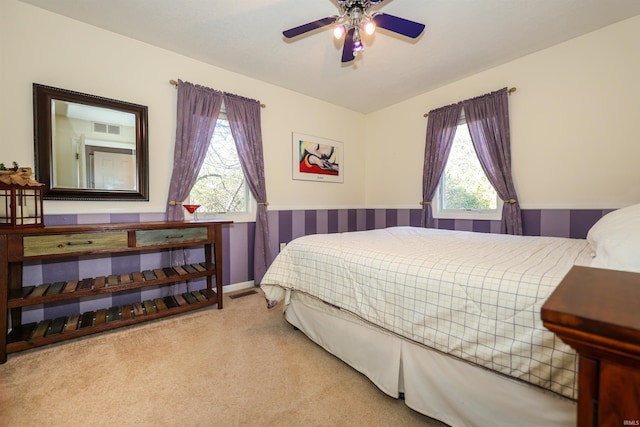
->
(433, 111, 502, 220)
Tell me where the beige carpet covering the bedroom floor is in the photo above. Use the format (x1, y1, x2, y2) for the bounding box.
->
(0, 292, 444, 426)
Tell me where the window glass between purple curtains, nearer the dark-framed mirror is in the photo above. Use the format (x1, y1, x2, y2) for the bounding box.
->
(189, 109, 255, 222)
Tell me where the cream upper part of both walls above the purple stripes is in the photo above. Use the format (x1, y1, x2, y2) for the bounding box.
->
(0, 0, 640, 213)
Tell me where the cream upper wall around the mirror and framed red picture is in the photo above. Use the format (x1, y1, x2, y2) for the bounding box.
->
(0, 0, 365, 214)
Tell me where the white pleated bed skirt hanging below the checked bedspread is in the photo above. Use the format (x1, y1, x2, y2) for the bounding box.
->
(285, 292, 576, 427)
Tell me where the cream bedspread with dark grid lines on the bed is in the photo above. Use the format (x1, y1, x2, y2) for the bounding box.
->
(261, 227, 591, 399)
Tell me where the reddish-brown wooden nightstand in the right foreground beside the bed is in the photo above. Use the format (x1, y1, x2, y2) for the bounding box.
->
(542, 266, 640, 427)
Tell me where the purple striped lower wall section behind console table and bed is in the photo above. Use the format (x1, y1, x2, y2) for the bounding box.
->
(23, 209, 612, 323)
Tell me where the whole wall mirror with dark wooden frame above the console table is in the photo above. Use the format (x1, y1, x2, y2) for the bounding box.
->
(33, 83, 149, 200)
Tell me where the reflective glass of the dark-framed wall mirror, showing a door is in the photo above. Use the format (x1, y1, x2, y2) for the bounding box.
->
(51, 99, 138, 190)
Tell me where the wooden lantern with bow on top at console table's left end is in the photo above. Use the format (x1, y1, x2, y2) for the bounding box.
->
(0, 162, 44, 228)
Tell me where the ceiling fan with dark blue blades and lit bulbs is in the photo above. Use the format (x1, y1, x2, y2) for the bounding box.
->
(282, 0, 425, 62)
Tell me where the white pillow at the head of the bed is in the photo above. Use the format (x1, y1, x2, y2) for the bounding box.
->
(587, 204, 640, 272)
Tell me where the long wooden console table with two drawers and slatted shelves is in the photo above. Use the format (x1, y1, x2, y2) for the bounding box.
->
(0, 221, 231, 363)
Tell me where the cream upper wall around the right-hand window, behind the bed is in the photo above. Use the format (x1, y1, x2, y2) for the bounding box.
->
(365, 16, 640, 209)
